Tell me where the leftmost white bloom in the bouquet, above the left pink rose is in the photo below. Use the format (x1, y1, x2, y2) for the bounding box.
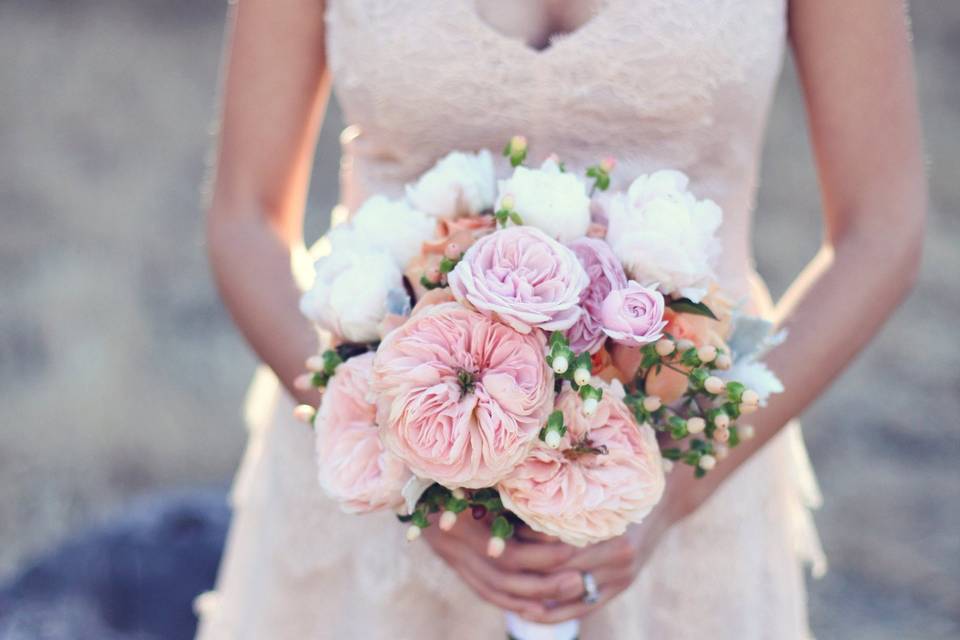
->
(300, 248, 403, 342)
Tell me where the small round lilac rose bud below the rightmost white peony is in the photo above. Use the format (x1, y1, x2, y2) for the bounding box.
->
(600, 280, 667, 346)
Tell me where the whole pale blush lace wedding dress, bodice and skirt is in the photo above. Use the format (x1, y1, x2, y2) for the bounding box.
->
(198, 0, 823, 640)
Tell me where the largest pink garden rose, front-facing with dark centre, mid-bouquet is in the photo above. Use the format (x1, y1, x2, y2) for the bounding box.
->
(376, 303, 553, 488)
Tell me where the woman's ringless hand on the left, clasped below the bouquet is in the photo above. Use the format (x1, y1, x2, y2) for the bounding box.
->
(423, 513, 583, 620)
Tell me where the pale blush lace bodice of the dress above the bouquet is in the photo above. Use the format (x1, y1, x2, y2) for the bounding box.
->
(327, 0, 785, 294)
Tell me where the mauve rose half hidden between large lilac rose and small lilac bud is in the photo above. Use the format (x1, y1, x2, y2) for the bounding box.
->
(567, 238, 627, 353)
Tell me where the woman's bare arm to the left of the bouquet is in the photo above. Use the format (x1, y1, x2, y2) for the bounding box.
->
(207, 0, 330, 404)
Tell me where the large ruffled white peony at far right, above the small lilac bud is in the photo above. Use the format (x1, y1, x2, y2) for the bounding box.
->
(606, 171, 723, 302)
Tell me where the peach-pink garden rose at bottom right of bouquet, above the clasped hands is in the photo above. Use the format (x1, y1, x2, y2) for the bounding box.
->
(497, 381, 664, 547)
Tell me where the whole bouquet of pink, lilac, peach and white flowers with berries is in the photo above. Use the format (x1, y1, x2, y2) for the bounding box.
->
(296, 137, 782, 635)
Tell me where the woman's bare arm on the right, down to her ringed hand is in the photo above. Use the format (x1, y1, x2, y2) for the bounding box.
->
(520, 0, 926, 622)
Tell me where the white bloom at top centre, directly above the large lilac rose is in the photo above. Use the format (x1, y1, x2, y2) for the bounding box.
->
(496, 160, 590, 243)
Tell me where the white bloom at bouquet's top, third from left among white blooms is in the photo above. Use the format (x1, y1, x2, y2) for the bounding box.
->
(407, 150, 496, 218)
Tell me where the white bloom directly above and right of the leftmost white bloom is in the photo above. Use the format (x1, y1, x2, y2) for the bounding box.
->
(348, 196, 436, 269)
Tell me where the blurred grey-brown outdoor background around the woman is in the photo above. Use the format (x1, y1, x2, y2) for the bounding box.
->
(0, 0, 960, 640)
